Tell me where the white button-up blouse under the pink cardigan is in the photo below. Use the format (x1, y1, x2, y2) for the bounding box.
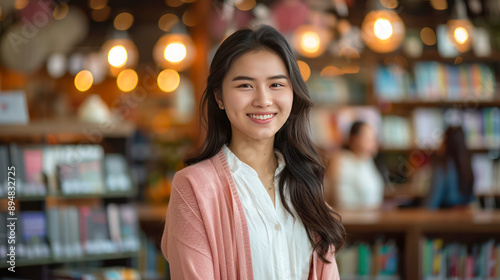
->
(223, 145, 313, 280)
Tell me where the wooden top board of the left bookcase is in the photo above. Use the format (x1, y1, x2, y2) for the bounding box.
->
(0, 119, 135, 138)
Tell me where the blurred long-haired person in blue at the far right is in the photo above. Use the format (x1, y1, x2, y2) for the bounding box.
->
(426, 127, 474, 209)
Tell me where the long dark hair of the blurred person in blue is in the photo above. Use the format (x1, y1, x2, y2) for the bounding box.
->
(438, 126, 474, 197)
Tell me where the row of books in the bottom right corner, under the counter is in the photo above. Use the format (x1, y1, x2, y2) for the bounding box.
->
(421, 239, 500, 280)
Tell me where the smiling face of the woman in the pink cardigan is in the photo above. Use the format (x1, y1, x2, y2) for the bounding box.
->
(216, 50, 293, 141)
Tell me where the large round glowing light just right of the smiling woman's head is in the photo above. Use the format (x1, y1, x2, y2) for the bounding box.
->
(293, 25, 331, 58)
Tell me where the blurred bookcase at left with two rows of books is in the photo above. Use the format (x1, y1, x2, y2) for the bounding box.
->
(0, 118, 141, 279)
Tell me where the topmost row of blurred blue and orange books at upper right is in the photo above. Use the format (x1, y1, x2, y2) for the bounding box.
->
(374, 61, 498, 101)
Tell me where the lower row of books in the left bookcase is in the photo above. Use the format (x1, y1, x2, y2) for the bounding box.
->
(0, 203, 139, 260)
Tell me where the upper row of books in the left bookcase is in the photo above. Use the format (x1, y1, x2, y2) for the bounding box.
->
(0, 144, 132, 197)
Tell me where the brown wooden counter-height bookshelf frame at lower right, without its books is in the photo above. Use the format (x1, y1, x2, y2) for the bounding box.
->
(340, 209, 500, 280)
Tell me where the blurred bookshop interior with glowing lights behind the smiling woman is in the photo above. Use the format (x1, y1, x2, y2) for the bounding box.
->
(0, 0, 500, 280)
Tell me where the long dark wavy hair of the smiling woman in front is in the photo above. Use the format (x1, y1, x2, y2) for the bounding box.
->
(184, 25, 345, 263)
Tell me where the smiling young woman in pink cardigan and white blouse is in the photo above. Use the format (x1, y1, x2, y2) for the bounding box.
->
(162, 26, 345, 279)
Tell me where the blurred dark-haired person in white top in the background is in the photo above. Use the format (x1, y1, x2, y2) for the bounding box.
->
(325, 121, 384, 210)
